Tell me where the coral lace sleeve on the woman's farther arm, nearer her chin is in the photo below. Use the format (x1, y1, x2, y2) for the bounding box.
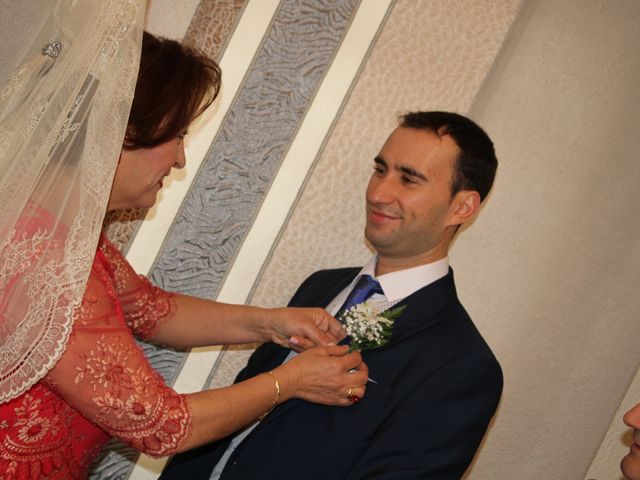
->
(99, 237, 176, 340)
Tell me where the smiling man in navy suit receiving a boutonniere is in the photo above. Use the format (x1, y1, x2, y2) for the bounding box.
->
(161, 112, 502, 480)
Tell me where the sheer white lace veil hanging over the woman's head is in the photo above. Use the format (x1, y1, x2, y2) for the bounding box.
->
(0, 0, 145, 403)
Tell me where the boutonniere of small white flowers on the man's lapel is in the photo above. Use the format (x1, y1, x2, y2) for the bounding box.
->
(340, 302, 407, 352)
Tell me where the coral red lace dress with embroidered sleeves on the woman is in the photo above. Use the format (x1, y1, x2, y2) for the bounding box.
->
(0, 237, 191, 480)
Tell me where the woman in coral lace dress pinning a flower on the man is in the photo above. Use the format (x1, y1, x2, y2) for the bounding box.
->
(0, 29, 367, 479)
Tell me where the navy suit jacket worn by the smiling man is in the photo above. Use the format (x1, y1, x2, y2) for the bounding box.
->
(160, 268, 502, 480)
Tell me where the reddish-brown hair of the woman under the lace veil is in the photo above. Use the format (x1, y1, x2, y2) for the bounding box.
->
(124, 32, 221, 150)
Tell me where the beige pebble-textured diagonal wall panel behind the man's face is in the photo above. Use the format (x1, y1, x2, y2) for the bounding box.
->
(252, 0, 520, 305)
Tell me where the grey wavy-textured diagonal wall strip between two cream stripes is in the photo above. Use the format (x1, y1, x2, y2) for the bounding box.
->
(139, 0, 358, 402)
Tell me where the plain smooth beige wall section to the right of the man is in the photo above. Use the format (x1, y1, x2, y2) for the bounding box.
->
(452, 0, 640, 480)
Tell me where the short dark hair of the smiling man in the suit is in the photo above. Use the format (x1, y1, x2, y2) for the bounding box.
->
(400, 112, 498, 201)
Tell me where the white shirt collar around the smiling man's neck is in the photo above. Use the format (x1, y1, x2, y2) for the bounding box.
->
(358, 255, 449, 302)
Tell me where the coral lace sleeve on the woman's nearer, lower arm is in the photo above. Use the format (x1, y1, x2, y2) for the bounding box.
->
(45, 261, 191, 457)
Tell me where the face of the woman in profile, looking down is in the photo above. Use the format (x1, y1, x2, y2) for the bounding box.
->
(107, 135, 185, 211)
